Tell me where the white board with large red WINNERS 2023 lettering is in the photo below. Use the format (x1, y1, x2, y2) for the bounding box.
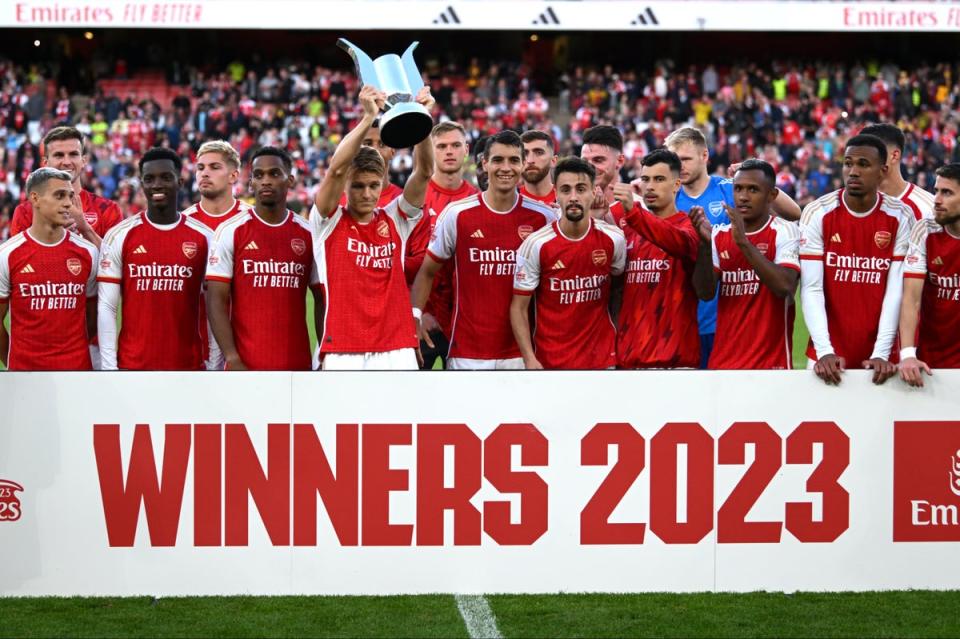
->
(0, 371, 960, 596)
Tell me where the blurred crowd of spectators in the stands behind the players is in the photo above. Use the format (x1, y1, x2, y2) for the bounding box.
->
(0, 53, 960, 239)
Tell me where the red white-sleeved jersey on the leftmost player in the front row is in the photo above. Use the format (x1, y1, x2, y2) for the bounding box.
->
(0, 232, 97, 371)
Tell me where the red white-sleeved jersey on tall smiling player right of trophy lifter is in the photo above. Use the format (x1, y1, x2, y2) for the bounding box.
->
(427, 193, 557, 359)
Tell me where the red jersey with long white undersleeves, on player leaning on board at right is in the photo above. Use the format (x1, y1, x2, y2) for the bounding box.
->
(800, 189, 914, 366)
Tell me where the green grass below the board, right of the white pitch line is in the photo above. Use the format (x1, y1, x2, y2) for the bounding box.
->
(489, 591, 960, 637)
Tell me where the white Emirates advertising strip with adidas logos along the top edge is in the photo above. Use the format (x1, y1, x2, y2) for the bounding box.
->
(0, 0, 960, 32)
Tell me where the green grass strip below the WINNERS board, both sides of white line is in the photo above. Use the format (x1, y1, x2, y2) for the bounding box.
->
(0, 591, 960, 639)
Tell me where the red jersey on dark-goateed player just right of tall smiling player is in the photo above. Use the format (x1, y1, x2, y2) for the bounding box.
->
(513, 220, 627, 369)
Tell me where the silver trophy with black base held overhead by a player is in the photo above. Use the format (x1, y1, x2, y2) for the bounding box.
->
(337, 38, 433, 149)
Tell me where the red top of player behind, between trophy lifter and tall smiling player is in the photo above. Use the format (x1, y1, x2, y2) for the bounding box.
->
(403, 175, 479, 335)
